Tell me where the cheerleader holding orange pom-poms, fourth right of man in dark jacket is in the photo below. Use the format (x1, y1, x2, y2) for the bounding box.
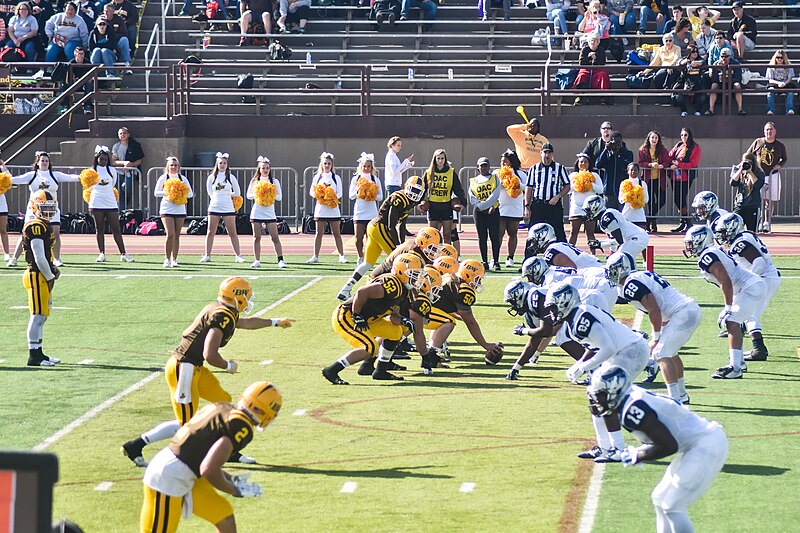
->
(306, 152, 347, 263)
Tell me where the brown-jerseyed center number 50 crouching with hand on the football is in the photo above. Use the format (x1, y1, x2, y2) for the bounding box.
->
(425, 259, 503, 360)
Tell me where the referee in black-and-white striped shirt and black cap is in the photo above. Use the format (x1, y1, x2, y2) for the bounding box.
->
(525, 143, 569, 242)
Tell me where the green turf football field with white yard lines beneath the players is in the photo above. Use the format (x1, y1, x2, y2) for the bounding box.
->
(0, 255, 800, 532)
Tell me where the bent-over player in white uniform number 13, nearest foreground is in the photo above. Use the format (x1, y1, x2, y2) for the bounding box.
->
(588, 367, 728, 533)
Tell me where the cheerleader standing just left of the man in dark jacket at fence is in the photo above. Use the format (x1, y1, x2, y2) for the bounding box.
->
(89, 146, 134, 263)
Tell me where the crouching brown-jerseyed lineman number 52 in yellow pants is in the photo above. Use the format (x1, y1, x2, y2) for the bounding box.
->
(322, 253, 422, 385)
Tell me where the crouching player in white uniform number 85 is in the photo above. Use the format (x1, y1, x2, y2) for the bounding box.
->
(545, 282, 650, 463)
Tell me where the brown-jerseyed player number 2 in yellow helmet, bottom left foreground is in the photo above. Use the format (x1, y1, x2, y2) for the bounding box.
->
(139, 381, 283, 533)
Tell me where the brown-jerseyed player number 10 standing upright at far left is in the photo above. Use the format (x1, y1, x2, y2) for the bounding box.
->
(22, 190, 61, 366)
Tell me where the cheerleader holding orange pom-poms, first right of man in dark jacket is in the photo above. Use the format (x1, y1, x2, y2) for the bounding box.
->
(154, 156, 194, 268)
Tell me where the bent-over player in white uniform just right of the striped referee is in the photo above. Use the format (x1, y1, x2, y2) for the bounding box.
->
(583, 194, 650, 257)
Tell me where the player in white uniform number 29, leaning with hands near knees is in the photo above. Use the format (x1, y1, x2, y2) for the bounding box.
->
(606, 252, 702, 404)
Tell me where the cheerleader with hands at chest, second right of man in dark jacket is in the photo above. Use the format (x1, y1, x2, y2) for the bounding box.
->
(200, 152, 244, 263)
